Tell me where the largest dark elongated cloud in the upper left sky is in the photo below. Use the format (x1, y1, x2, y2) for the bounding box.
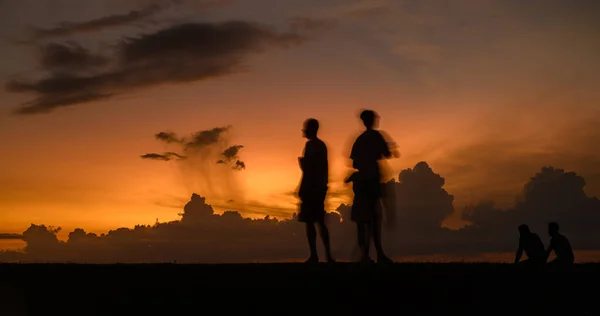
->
(6, 21, 304, 114)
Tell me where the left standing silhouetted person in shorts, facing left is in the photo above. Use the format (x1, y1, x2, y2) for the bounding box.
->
(298, 118, 334, 263)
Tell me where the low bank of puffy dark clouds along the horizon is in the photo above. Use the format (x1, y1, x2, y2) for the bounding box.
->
(4, 162, 600, 262)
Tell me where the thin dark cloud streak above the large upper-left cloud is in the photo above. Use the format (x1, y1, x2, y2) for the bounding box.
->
(33, 5, 164, 40)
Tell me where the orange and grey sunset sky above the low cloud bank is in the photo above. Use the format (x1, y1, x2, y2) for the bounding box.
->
(0, 0, 600, 238)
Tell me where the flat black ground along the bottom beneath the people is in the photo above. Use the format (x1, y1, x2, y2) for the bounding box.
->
(0, 263, 600, 316)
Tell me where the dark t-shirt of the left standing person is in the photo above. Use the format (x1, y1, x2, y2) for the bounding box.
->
(300, 138, 329, 196)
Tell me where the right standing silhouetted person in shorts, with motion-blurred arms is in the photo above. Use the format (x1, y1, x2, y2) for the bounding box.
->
(346, 110, 392, 262)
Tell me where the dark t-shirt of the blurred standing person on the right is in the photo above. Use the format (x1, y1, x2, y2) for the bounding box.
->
(350, 129, 391, 176)
